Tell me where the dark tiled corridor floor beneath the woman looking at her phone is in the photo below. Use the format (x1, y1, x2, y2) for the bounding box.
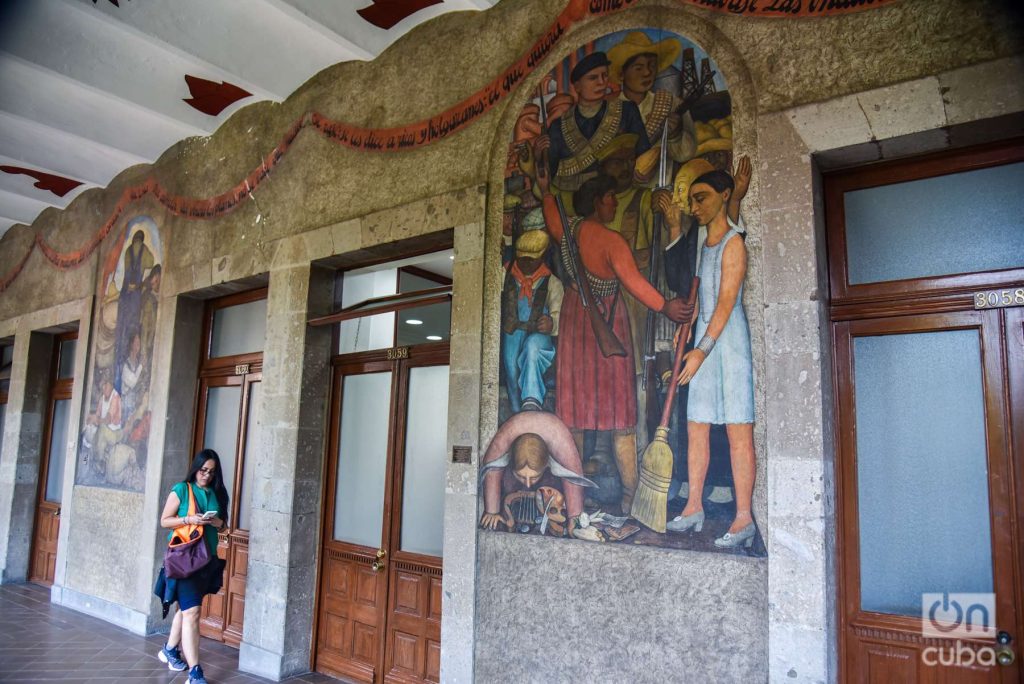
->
(0, 585, 338, 684)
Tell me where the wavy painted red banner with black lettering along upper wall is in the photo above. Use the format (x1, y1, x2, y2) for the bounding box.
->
(0, 0, 899, 293)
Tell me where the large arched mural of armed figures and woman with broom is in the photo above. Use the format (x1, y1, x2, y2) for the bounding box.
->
(480, 29, 764, 555)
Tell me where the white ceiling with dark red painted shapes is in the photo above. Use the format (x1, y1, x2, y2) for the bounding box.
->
(0, 0, 497, 240)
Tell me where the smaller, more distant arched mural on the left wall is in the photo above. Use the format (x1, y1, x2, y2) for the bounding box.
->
(76, 216, 163, 491)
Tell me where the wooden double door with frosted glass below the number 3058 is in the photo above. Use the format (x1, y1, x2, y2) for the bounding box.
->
(836, 311, 1021, 683)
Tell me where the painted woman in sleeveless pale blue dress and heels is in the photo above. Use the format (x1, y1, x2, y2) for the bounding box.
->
(667, 170, 757, 548)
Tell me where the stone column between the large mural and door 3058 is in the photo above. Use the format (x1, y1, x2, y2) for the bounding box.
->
(755, 109, 836, 682)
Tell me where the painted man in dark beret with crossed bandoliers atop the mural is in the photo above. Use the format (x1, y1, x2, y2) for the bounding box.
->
(534, 52, 650, 193)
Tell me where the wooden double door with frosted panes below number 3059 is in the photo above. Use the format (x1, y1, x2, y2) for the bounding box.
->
(314, 343, 449, 682)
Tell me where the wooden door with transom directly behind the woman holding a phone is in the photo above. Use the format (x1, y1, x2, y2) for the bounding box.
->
(193, 289, 266, 647)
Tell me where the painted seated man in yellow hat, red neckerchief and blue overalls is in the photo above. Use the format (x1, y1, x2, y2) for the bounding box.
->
(502, 227, 564, 413)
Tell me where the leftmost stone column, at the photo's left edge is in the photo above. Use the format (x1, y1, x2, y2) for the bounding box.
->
(0, 325, 53, 583)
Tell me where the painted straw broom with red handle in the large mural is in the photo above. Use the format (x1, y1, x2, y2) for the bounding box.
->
(630, 277, 700, 533)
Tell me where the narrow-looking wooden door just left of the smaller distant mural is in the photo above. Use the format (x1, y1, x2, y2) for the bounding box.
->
(29, 331, 78, 586)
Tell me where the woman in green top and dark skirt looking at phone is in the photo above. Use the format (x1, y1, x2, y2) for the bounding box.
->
(156, 448, 228, 684)
